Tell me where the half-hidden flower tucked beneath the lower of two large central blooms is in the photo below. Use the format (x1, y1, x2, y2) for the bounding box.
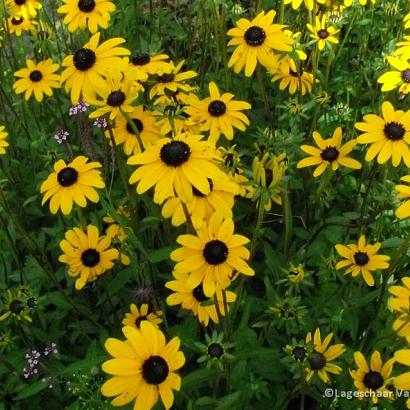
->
(165, 271, 236, 326)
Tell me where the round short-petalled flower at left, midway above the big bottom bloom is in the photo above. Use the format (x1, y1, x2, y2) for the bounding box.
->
(58, 225, 119, 290)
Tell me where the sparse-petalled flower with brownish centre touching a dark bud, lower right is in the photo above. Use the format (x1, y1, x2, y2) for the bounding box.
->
(306, 328, 346, 383)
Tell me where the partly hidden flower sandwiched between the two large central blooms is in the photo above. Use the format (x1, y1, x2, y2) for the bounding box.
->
(161, 178, 239, 229)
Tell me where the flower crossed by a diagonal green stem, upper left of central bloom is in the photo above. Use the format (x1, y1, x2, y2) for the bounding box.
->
(106, 105, 162, 156)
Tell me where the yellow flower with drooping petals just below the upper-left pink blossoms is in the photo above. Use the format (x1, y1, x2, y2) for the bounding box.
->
(40, 155, 105, 215)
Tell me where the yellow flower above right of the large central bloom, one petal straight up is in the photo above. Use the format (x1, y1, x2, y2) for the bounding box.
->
(185, 81, 251, 143)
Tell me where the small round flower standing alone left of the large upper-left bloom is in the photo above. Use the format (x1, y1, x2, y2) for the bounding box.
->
(13, 58, 61, 102)
